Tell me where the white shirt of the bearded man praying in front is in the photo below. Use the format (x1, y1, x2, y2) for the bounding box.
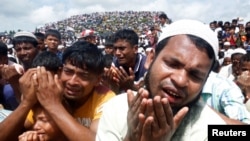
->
(96, 94, 226, 141)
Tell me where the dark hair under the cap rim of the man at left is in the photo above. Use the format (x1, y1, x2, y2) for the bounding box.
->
(13, 36, 38, 48)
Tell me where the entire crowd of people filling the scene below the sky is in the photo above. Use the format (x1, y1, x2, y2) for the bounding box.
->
(0, 11, 250, 141)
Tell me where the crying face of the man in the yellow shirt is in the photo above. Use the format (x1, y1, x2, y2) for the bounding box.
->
(60, 63, 101, 101)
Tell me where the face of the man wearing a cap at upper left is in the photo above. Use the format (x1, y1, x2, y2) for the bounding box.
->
(15, 43, 38, 65)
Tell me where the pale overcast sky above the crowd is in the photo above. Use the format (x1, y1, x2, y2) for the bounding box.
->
(0, 0, 250, 32)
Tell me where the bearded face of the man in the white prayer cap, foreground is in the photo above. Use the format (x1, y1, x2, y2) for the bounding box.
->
(145, 35, 212, 108)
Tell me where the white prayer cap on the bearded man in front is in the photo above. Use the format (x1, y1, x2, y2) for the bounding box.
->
(158, 19, 219, 59)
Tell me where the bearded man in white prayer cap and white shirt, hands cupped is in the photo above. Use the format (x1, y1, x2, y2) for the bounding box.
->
(96, 19, 225, 141)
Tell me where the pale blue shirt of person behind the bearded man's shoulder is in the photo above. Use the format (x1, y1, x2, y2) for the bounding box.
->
(201, 72, 250, 123)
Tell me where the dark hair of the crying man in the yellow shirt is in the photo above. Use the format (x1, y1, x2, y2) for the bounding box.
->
(62, 41, 105, 74)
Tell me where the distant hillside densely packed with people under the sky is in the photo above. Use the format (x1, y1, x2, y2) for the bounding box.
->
(36, 11, 162, 38)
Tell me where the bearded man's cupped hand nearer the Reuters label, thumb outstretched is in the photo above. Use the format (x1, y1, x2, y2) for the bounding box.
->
(141, 96, 188, 141)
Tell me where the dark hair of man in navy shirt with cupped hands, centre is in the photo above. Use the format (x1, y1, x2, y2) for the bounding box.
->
(113, 29, 139, 45)
